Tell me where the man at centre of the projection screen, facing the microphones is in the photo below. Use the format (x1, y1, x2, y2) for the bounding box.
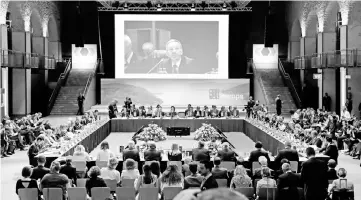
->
(159, 39, 194, 74)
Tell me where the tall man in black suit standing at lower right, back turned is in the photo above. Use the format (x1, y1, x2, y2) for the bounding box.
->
(301, 147, 328, 200)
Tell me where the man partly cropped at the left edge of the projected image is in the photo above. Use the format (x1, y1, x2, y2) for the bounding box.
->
(124, 35, 139, 73)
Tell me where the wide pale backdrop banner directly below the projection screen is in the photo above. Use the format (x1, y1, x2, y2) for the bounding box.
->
(101, 79, 249, 108)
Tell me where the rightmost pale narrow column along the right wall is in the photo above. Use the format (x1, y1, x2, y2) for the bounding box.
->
(340, 25, 348, 113)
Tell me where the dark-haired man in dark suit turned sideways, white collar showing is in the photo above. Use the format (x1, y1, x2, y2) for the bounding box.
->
(198, 161, 218, 191)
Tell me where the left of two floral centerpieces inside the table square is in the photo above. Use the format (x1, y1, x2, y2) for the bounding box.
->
(137, 124, 166, 142)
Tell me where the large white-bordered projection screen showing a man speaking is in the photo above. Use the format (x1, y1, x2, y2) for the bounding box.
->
(114, 14, 229, 79)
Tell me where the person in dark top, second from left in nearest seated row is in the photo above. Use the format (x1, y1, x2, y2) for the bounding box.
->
(40, 161, 70, 200)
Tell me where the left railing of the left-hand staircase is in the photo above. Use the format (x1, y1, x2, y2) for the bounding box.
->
(47, 58, 72, 115)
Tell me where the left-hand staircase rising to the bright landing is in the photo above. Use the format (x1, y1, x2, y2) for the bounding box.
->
(51, 69, 94, 115)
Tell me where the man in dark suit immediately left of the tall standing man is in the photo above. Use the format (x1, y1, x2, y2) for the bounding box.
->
(277, 163, 301, 200)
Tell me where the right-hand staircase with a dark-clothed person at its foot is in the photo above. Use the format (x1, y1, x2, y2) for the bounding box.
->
(257, 68, 297, 114)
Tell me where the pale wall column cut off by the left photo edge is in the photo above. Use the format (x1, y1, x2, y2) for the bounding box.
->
(0, 24, 9, 119)
